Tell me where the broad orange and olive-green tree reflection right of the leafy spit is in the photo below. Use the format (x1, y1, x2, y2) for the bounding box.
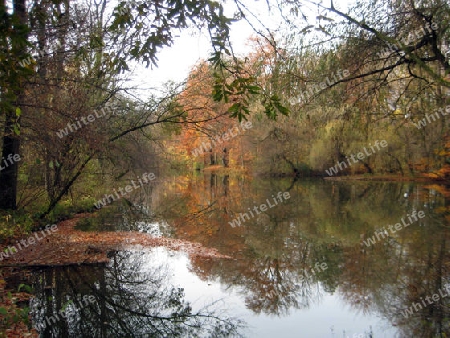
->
(152, 174, 450, 337)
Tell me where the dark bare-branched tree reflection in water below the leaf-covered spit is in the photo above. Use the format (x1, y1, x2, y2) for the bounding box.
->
(31, 251, 244, 338)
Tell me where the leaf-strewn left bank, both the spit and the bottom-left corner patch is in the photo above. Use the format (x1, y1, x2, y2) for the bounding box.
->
(0, 213, 231, 337)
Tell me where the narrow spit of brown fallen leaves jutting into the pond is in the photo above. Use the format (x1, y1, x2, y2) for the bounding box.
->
(0, 213, 231, 267)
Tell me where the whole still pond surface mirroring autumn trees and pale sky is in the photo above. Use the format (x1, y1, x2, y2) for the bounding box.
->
(8, 174, 450, 338)
